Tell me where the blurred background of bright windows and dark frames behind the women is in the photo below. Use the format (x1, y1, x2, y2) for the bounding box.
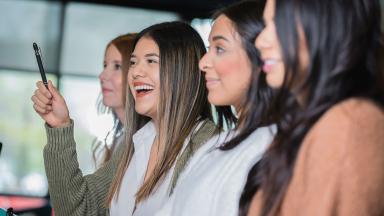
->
(0, 0, 234, 215)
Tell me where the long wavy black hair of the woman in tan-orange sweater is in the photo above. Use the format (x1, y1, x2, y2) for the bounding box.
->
(240, 0, 384, 215)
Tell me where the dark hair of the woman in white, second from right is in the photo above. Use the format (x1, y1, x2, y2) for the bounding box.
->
(213, 0, 272, 150)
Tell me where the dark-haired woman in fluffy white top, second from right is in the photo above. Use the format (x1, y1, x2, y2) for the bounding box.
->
(157, 1, 274, 216)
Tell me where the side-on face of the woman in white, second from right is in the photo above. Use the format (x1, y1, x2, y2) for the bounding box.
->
(199, 15, 252, 111)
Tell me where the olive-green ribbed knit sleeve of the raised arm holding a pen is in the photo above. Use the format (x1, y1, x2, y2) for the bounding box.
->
(44, 121, 124, 216)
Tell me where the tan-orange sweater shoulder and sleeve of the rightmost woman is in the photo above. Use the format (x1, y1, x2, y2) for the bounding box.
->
(283, 98, 384, 215)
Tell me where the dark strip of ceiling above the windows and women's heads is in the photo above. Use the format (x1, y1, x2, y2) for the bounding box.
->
(58, 0, 237, 20)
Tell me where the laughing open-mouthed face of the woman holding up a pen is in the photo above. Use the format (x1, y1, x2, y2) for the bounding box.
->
(128, 37, 160, 119)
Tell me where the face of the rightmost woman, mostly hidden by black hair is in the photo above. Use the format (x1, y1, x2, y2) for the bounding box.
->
(255, 0, 309, 88)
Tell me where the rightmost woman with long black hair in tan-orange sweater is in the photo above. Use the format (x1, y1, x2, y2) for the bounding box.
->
(240, 0, 384, 216)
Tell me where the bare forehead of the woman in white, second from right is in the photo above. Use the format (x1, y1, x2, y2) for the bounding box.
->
(209, 15, 236, 41)
